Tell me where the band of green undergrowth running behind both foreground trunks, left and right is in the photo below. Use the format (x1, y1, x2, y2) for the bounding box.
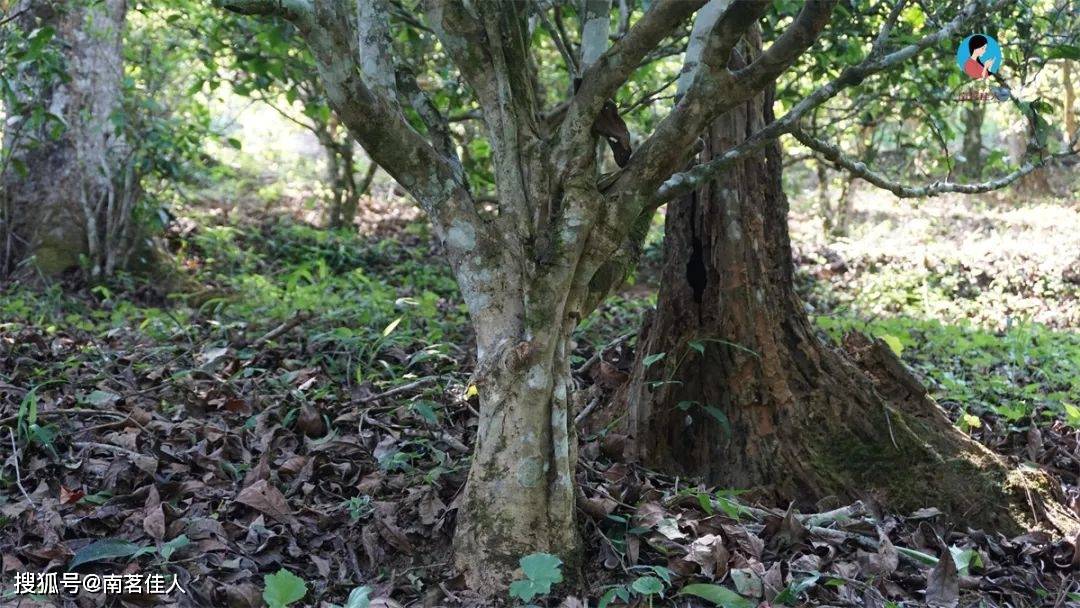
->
(8, 210, 1080, 438)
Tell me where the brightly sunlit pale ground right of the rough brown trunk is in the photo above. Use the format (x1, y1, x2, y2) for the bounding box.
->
(792, 188, 1080, 329)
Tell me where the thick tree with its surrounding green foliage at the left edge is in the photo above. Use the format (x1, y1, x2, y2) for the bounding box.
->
(0, 1, 210, 280)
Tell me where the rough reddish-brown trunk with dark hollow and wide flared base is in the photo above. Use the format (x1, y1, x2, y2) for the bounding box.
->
(630, 84, 1062, 531)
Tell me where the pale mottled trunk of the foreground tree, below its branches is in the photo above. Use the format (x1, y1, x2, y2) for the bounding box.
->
(447, 183, 595, 593)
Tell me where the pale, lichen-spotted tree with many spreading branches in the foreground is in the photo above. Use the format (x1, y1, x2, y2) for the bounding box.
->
(214, 0, 1075, 592)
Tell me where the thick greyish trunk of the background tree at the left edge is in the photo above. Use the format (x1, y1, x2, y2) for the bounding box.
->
(2, 0, 131, 274)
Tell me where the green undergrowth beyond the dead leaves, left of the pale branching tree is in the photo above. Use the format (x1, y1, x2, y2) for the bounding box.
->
(0, 221, 469, 384)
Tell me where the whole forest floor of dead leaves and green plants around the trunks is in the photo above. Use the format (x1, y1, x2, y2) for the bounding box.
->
(0, 187, 1080, 608)
